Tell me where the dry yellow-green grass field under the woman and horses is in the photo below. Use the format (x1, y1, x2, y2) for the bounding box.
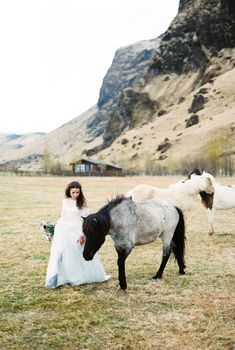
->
(0, 176, 235, 350)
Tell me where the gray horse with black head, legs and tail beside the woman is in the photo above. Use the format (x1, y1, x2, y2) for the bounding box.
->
(83, 196, 185, 290)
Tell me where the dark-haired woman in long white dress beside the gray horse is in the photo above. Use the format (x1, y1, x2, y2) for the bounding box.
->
(45, 181, 109, 288)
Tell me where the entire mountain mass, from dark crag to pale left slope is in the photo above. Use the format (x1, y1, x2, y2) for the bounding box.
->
(1, 0, 235, 170)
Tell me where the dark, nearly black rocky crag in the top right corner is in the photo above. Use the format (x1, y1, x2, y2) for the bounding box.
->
(150, 0, 235, 74)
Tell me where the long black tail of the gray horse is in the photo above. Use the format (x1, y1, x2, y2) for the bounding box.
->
(172, 207, 186, 267)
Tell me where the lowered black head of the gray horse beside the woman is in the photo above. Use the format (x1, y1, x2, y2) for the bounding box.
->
(83, 214, 110, 260)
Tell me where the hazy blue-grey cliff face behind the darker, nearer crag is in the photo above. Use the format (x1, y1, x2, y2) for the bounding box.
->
(88, 38, 160, 137)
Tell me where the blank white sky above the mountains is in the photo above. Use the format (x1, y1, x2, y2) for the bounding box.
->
(0, 0, 179, 133)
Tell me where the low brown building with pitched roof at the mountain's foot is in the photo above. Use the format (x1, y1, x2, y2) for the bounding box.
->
(70, 158, 122, 176)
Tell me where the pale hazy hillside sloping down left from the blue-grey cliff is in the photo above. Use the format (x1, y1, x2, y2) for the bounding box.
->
(0, 106, 99, 170)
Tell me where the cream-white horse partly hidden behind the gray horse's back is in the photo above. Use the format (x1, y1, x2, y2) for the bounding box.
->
(126, 172, 214, 211)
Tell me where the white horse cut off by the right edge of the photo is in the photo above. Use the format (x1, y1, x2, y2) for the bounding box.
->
(192, 170, 235, 235)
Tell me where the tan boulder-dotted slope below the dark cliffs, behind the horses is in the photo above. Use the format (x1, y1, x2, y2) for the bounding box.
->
(99, 68, 235, 173)
